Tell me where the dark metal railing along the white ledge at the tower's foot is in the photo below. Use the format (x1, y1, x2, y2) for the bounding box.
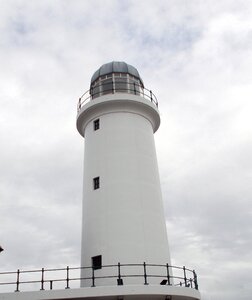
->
(0, 262, 198, 293)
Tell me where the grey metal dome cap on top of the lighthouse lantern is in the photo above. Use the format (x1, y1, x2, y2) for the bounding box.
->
(91, 61, 144, 87)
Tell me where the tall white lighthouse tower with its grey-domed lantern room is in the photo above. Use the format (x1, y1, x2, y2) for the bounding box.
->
(77, 61, 199, 299)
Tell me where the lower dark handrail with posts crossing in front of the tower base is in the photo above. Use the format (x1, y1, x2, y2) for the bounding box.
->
(0, 262, 198, 293)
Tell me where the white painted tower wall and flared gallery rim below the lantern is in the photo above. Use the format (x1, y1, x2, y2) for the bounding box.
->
(77, 94, 170, 286)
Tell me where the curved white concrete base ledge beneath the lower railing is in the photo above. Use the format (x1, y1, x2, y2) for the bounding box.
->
(0, 285, 200, 300)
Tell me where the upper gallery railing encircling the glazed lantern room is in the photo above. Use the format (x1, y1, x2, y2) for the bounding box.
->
(77, 80, 158, 112)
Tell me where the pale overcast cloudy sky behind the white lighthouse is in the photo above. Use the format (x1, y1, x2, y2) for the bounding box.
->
(0, 0, 252, 300)
